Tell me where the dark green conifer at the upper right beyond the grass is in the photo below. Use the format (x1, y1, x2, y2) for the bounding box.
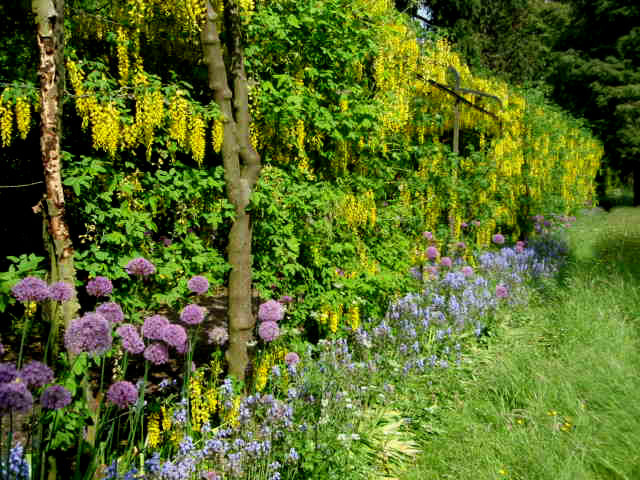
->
(548, 0, 640, 205)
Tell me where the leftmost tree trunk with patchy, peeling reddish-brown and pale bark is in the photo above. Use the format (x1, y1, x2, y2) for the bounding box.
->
(32, 0, 78, 361)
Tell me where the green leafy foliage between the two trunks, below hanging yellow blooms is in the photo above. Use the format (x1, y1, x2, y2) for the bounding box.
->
(64, 155, 233, 310)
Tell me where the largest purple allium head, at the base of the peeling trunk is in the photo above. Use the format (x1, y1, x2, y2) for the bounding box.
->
(64, 313, 113, 355)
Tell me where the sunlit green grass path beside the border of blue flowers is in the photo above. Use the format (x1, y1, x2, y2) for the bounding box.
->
(401, 208, 640, 480)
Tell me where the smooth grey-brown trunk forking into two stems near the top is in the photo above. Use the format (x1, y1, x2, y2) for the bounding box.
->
(202, 0, 261, 379)
